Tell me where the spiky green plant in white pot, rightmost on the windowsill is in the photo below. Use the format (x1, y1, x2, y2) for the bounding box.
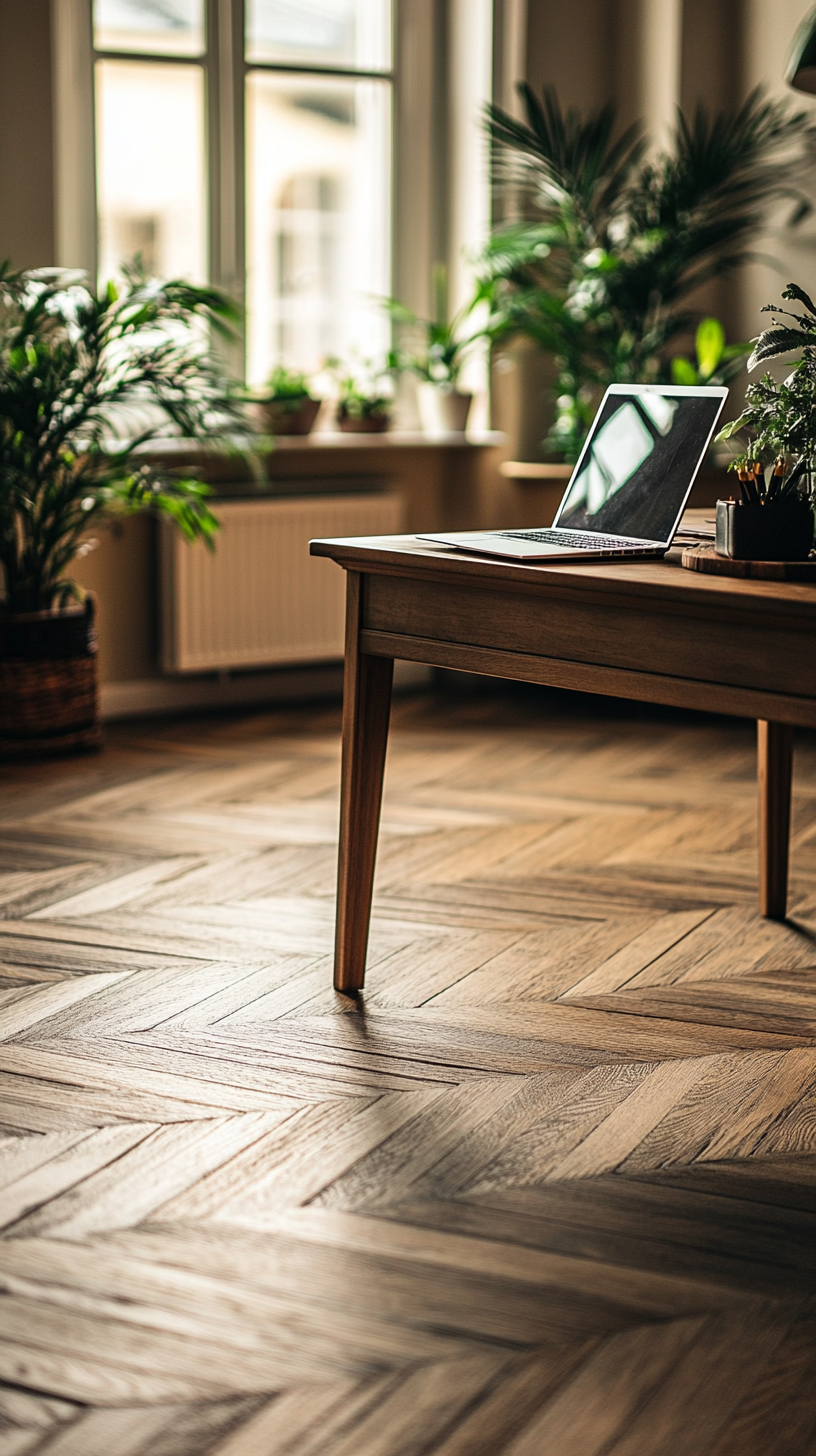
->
(385, 264, 484, 435)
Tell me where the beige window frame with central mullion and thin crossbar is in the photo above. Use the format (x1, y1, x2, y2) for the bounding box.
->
(51, 0, 498, 410)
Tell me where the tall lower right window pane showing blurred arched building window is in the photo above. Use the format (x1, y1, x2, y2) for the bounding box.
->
(246, 71, 391, 384)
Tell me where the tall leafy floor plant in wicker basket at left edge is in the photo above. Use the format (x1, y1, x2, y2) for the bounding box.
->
(0, 264, 240, 756)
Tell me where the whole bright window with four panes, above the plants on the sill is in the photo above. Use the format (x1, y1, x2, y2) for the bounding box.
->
(93, 0, 393, 384)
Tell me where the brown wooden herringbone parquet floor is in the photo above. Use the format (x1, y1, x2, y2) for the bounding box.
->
(0, 689, 816, 1456)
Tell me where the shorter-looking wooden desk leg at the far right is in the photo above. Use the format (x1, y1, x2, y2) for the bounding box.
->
(756, 718, 793, 920)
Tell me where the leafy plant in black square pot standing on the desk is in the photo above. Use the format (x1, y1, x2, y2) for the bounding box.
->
(717, 282, 816, 561)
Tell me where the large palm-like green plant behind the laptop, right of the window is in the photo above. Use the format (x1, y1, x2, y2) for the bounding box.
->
(479, 84, 816, 459)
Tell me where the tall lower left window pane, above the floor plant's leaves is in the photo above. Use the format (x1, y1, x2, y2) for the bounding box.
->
(96, 61, 207, 282)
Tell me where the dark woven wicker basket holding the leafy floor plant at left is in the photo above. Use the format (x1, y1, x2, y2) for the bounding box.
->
(0, 596, 102, 759)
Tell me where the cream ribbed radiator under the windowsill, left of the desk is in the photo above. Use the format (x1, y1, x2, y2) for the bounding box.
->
(160, 494, 402, 673)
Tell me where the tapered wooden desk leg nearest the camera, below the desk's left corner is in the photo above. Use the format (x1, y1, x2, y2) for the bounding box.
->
(334, 571, 393, 992)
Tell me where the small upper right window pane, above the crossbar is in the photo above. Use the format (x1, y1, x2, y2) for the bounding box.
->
(246, 0, 391, 70)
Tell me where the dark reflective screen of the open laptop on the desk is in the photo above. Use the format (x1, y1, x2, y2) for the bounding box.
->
(555, 386, 727, 542)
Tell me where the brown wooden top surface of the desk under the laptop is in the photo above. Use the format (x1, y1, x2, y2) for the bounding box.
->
(310, 511, 816, 625)
